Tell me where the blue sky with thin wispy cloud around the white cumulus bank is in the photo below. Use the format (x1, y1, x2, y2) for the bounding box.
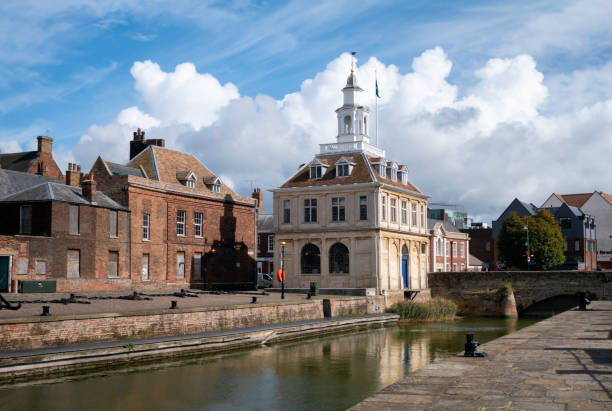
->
(0, 0, 612, 222)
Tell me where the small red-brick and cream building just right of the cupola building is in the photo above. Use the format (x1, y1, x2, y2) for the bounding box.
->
(427, 219, 470, 272)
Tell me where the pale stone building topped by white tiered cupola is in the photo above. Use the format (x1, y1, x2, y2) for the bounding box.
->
(271, 70, 429, 298)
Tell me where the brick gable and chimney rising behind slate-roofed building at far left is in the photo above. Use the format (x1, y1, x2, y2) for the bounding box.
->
(0, 136, 64, 180)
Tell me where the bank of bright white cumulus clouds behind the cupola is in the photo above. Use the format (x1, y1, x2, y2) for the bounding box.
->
(73, 47, 612, 224)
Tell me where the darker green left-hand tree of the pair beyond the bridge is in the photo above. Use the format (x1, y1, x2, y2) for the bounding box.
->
(497, 213, 527, 268)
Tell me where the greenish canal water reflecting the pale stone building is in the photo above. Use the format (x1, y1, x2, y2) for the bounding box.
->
(0, 318, 537, 410)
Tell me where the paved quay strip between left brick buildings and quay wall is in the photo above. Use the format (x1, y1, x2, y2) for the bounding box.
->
(0, 289, 322, 321)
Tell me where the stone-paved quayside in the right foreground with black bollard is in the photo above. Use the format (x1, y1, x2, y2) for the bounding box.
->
(352, 301, 612, 411)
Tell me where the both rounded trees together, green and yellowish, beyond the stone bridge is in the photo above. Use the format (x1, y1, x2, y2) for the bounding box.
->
(498, 210, 565, 270)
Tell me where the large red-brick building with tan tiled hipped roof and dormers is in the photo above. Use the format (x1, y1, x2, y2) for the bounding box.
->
(91, 129, 256, 288)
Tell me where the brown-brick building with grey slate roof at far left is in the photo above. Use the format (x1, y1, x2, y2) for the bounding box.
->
(0, 165, 129, 291)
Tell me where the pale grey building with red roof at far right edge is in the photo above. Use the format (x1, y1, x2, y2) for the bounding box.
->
(541, 191, 612, 269)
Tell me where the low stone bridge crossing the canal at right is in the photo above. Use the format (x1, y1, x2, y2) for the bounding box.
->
(428, 271, 612, 314)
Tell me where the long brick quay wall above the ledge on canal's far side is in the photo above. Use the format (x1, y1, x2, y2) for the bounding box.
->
(0, 297, 384, 351)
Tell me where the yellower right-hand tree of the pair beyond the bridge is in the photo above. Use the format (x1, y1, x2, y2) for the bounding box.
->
(524, 210, 565, 270)
